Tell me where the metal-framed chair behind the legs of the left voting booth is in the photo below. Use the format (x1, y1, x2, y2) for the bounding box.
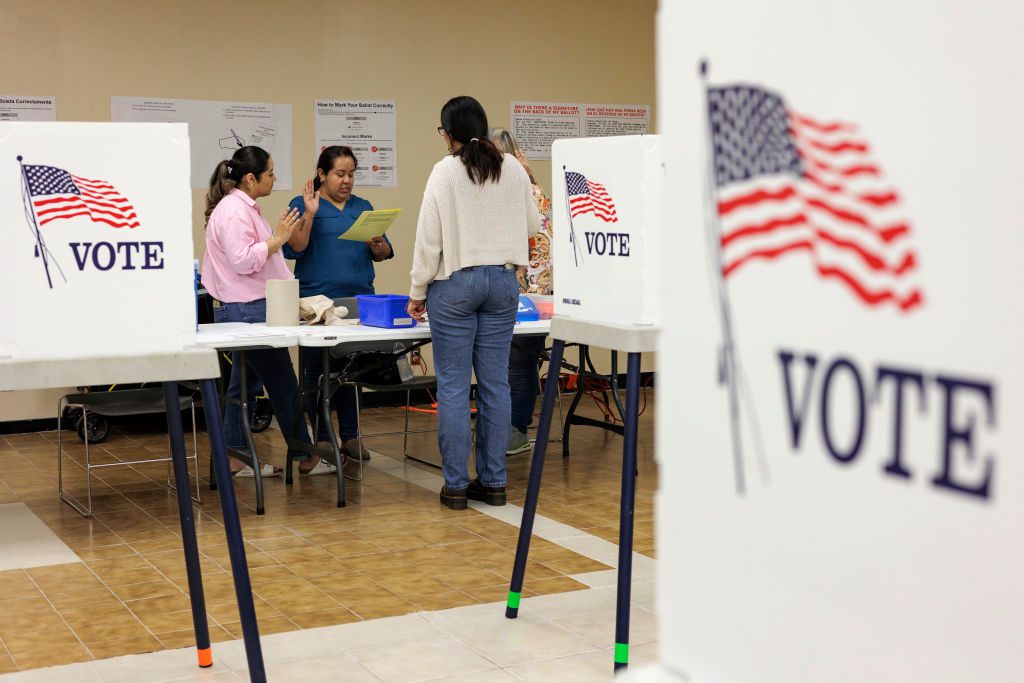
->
(57, 386, 202, 517)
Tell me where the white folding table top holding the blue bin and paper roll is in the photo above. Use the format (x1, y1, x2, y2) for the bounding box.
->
(188, 321, 551, 349)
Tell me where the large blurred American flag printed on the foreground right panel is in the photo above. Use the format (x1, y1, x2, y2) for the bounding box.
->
(708, 86, 924, 311)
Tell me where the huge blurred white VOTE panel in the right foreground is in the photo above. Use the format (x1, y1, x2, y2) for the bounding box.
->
(656, 0, 1024, 683)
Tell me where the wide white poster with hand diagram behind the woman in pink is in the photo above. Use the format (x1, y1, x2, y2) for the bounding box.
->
(111, 97, 292, 189)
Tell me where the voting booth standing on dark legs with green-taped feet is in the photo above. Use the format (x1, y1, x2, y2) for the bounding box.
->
(505, 135, 665, 671)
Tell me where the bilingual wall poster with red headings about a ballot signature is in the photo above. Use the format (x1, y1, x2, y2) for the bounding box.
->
(510, 101, 650, 159)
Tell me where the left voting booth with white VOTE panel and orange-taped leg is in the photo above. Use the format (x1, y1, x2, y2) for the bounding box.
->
(0, 122, 266, 681)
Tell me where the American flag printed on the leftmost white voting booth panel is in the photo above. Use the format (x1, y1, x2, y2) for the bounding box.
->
(24, 165, 138, 227)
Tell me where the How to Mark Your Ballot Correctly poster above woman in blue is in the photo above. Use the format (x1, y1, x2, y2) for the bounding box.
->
(313, 99, 398, 188)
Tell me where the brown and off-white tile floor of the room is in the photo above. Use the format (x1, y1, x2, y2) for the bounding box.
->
(0, 396, 656, 682)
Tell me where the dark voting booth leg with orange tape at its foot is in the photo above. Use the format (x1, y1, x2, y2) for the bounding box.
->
(164, 382, 213, 668)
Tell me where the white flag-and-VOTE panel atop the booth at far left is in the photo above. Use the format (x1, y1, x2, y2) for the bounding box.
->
(0, 122, 196, 360)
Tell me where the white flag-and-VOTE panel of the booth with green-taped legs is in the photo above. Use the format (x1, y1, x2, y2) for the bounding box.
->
(551, 135, 665, 325)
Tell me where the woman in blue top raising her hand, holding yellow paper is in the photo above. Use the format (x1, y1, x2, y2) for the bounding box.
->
(284, 145, 394, 460)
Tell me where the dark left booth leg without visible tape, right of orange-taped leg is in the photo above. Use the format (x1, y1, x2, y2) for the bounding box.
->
(200, 380, 266, 683)
